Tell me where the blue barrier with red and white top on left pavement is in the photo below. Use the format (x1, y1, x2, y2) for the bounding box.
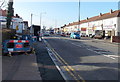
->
(2, 40, 33, 55)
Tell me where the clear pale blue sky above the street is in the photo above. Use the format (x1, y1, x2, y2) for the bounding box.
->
(13, 1, 118, 28)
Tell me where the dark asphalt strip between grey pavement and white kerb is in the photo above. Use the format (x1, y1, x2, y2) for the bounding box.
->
(34, 42, 64, 82)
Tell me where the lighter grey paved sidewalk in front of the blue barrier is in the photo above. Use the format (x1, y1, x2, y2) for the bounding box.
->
(2, 54, 41, 80)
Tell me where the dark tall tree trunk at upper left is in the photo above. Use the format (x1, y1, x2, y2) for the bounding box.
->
(7, 0, 14, 28)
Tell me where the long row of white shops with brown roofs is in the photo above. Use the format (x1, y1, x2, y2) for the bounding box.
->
(54, 10, 120, 42)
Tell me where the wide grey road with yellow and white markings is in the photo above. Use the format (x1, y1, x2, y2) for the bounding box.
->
(44, 36, 120, 82)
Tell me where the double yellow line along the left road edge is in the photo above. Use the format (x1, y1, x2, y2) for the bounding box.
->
(44, 41, 85, 82)
